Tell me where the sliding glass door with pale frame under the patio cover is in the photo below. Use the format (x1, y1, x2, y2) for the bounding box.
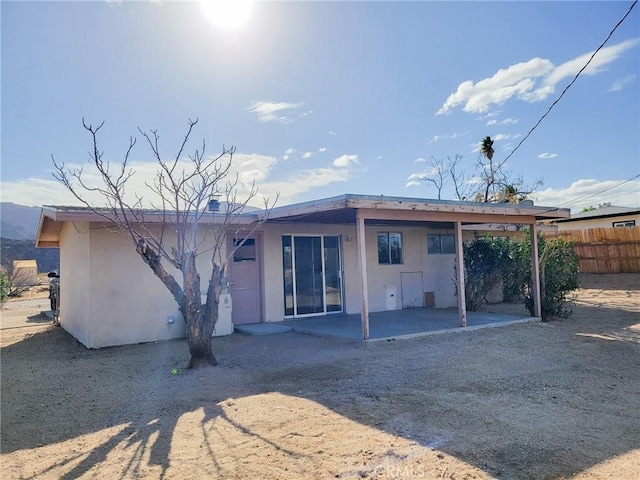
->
(282, 235, 342, 317)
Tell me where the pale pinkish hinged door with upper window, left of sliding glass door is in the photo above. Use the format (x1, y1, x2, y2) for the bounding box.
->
(229, 238, 262, 325)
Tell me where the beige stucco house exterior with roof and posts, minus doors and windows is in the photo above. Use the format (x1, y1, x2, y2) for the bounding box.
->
(36, 195, 569, 348)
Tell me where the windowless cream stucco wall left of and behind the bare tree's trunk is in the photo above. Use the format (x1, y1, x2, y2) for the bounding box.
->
(60, 222, 230, 348)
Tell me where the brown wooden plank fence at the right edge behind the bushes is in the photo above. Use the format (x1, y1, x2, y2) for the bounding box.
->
(543, 226, 640, 273)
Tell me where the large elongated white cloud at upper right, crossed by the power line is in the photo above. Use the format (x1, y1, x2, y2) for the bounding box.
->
(436, 39, 640, 115)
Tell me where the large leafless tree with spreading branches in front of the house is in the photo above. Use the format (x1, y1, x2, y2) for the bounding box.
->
(52, 119, 277, 368)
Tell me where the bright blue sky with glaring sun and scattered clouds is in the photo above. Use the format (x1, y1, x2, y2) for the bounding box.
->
(0, 0, 640, 212)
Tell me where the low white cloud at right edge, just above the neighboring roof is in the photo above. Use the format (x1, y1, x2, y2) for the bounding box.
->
(535, 179, 640, 212)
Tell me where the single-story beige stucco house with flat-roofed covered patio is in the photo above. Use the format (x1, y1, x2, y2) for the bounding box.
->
(36, 194, 569, 348)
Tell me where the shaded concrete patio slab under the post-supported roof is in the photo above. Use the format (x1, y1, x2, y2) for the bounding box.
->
(235, 308, 539, 341)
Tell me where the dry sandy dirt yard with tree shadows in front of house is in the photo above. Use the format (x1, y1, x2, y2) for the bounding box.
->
(0, 274, 640, 480)
